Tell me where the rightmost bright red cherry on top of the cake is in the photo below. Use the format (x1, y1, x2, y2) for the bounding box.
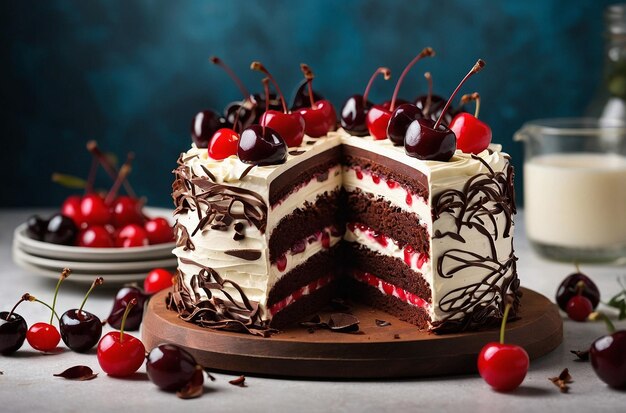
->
(449, 93, 491, 154)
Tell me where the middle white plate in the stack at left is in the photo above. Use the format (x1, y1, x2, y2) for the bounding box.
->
(13, 245, 177, 275)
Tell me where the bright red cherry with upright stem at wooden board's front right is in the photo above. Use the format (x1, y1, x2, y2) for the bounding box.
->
(478, 303, 529, 391)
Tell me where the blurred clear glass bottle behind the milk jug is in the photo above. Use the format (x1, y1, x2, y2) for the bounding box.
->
(586, 4, 626, 123)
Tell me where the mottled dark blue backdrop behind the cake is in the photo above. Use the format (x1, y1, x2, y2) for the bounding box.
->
(0, 0, 610, 206)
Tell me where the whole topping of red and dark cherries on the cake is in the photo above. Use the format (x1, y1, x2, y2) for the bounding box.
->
(192, 47, 491, 166)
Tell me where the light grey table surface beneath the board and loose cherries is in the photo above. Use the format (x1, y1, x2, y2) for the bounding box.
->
(0, 209, 626, 413)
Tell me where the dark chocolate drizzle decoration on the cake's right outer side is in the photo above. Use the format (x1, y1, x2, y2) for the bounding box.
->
(432, 155, 521, 333)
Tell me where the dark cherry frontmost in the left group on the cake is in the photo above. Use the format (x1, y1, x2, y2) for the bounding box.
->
(237, 125, 287, 166)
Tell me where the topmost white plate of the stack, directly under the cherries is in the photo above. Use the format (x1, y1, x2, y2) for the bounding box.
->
(13, 207, 176, 262)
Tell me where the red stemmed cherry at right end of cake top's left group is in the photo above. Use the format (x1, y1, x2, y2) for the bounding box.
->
(297, 63, 337, 138)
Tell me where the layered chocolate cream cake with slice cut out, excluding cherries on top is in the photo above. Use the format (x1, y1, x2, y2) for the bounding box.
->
(168, 129, 520, 335)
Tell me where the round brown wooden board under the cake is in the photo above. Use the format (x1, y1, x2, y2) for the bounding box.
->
(142, 289, 563, 379)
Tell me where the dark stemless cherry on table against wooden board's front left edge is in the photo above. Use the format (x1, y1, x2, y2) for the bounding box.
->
(146, 344, 198, 391)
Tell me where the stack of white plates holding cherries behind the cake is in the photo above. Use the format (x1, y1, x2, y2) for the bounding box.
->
(13, 208, 177, 284)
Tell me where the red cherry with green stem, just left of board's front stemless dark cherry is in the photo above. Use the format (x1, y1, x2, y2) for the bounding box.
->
(98, 298, 146, 377)
